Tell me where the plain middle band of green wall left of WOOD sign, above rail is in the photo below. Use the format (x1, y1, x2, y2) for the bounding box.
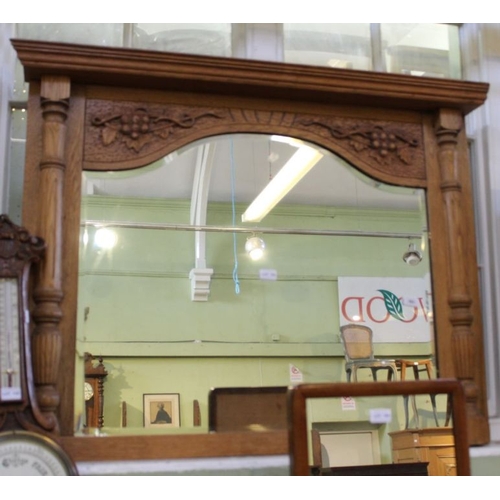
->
(80, 275, 339, 343)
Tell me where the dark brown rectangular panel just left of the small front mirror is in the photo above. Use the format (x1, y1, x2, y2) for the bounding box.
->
(208, 386, 288, 432)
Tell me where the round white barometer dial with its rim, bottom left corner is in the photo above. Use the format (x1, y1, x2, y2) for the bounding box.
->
(0, 431, 78, 476)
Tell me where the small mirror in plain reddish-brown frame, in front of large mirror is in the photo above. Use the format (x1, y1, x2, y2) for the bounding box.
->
(288, 379, 470, 476)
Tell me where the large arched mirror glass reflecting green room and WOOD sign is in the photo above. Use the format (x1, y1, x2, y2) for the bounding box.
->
(76, 134, 437, 433)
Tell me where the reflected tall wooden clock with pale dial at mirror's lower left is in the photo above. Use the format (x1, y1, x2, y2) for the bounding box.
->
(84, 352, 107, 429)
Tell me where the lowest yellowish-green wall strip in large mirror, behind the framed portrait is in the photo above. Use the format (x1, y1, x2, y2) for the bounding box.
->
(89, 357, 343, 429)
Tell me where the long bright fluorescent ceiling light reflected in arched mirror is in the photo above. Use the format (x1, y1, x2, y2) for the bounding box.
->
(241, 146, 323, 222)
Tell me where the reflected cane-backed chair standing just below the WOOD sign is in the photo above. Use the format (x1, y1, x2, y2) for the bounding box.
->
(340, 324, 397, 382)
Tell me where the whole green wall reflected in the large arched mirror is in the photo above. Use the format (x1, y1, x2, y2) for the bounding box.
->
(77, 196, 430, 426)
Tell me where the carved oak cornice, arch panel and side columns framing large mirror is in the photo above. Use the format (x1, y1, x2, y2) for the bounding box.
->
(13, 40, 489, 444)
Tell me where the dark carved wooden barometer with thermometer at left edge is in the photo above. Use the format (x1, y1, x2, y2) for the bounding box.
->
(0, 215, 77, 476)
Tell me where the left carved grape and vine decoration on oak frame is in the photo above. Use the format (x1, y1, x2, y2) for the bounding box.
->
(91, 108, 222, 153)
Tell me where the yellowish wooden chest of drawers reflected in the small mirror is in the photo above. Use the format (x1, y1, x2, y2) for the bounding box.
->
(389, 427, 456, 476)
